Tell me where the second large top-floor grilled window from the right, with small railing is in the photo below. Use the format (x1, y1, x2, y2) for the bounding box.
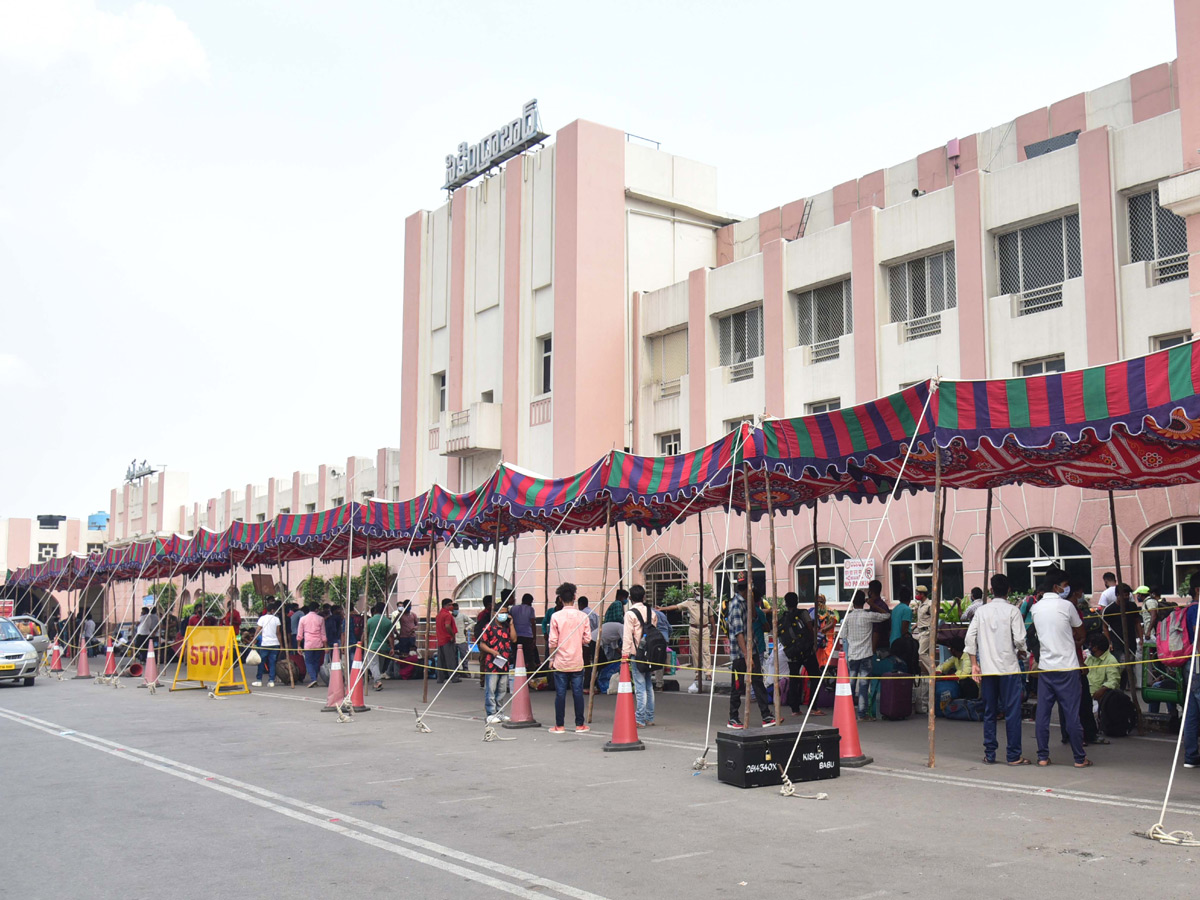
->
(996, 212, 1084, 316)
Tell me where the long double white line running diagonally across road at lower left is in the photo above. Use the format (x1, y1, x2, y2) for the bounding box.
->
(0, 710, 606, 900)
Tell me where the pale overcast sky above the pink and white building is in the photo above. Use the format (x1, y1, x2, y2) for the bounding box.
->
(0, 0, 1176, 517)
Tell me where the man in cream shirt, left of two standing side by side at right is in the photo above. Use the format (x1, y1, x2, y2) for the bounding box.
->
(966, 574, 1030, 766)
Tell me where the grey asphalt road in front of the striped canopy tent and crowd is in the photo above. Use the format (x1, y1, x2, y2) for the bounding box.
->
(7, 679, 1200, 900)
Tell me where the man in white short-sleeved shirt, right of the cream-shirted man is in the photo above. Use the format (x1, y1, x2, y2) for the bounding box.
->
(1032, 566, 1092, 769)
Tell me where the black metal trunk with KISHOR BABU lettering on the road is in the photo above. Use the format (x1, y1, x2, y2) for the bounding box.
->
(716, 725, 841, 787)
